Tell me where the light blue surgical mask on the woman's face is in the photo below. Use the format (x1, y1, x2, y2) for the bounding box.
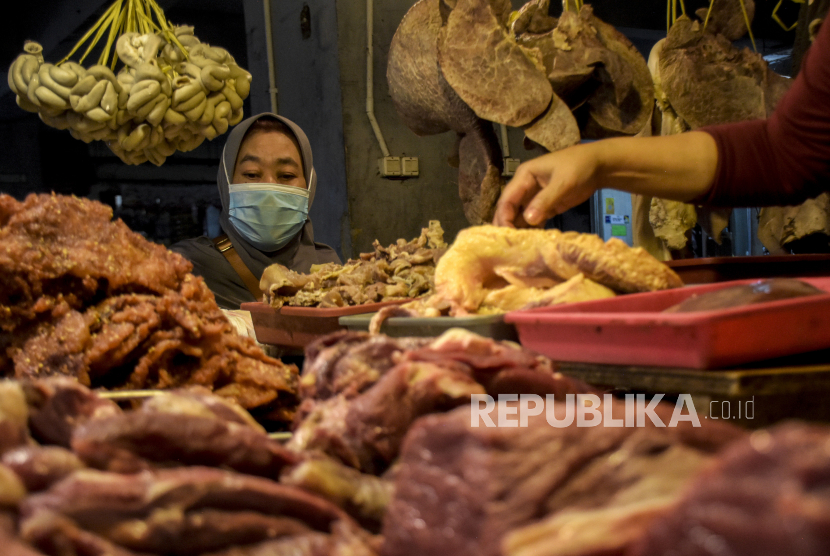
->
(228, 183, 308, 251)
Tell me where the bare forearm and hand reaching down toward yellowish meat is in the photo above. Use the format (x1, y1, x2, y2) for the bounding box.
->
(493, 131, 718, 227)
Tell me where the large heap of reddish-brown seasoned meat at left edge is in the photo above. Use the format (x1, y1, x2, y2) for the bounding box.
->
(0, 195, 296, 408)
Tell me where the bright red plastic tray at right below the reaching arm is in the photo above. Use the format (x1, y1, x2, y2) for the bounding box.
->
(505, 277, 830, 369)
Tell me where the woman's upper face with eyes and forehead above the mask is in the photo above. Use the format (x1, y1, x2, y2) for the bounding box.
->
(233, 131, 308, 189)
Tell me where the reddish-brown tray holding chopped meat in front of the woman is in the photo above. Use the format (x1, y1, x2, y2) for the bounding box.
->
(240, 299, 412, 348)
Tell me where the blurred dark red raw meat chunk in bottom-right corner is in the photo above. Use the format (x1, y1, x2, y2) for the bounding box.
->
(627, 423, 830, 556)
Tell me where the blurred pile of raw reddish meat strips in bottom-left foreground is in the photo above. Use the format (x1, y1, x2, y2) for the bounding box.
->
(0, 378, 377, 556)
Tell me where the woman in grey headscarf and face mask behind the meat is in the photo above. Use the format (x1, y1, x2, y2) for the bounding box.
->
(170, 113, 340, 309)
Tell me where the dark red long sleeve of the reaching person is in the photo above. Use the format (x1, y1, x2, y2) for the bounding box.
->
(695, 22, 830, 206)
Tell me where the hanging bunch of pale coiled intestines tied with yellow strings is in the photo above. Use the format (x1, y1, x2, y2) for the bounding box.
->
(8, 0, 251, 166)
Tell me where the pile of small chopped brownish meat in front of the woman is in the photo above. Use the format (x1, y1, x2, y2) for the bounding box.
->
(260, 220, 447, 309)
